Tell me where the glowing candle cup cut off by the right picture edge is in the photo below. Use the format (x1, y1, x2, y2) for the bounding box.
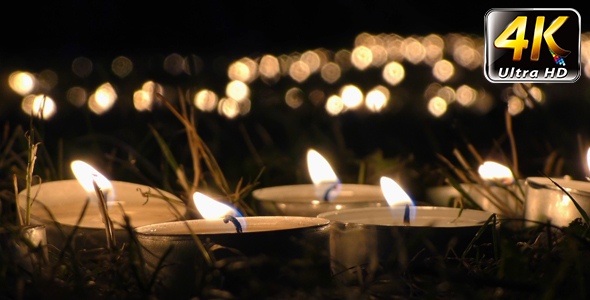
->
(524, 177, 590, 226)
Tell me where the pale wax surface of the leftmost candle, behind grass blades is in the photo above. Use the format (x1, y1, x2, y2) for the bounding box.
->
(19, 180, 186, 228)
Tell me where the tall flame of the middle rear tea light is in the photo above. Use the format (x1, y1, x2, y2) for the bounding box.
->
(307, 149, 342, 201)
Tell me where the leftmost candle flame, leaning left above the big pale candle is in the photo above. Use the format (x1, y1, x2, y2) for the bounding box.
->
(70, 160, 115, 206)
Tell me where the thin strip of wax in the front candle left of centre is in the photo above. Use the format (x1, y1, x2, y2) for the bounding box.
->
(137, 217, 329, 236)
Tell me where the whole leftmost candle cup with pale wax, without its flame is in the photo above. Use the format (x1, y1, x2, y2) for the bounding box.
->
(19, 180, 186, 249)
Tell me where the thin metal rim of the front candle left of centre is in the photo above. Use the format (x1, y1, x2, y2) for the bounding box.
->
(135, 216, 331, 239)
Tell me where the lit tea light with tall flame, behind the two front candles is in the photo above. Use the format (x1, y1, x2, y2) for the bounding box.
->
(252, 149, 387, 217)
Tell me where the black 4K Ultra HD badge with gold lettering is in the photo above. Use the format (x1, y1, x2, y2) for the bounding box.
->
(484, 8, 581, 82)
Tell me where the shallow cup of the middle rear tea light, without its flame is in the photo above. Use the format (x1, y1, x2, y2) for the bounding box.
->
(252, 184, 387, 217)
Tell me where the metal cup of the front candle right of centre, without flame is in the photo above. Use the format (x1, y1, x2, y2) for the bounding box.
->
(318, 206, 491, 283)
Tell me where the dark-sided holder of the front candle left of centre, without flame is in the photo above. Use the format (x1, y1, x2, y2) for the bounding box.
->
(136, 216, 330, 298)
